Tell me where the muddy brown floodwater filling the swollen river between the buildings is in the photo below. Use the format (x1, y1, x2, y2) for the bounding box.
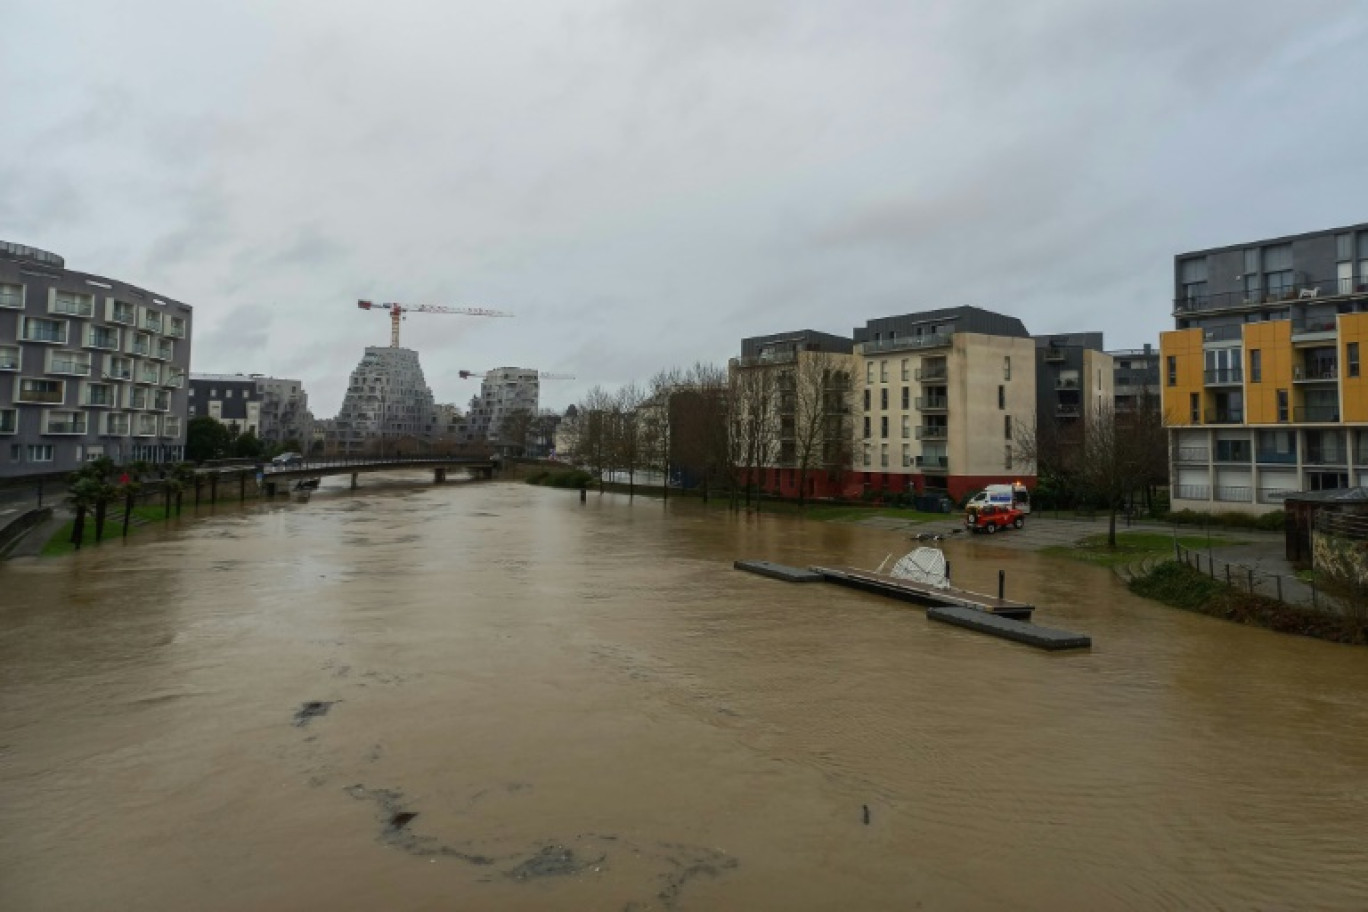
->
(0, 480, 1368, 912)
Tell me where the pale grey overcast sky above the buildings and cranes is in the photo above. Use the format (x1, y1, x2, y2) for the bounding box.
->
(0, 0, 1368, 417)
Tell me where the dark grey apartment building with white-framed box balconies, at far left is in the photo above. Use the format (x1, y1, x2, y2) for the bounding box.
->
(0, 241, 192, 477)
